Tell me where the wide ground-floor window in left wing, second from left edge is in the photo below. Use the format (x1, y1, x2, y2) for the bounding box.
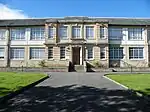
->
(10, 47, 25, 60)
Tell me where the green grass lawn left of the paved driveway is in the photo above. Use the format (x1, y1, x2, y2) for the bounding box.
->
(0, 72, 47, 97)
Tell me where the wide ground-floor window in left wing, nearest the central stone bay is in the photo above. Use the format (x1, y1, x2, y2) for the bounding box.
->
(30, 48, 45, 59)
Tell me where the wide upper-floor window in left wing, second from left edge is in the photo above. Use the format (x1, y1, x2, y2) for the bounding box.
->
(10, 28, 26, 41)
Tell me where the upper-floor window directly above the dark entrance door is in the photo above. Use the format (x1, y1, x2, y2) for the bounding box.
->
(72, 26, 81, 38)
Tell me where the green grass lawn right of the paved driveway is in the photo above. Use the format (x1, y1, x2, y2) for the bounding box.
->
(107, 74, 150, 95)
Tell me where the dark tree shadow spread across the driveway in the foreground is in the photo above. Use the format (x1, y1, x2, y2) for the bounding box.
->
(0, 85, 150, 112)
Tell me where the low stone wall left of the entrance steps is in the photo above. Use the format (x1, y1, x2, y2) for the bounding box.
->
(0, 66, 68, 72)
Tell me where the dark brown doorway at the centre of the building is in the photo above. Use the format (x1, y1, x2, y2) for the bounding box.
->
(72, 47, 80, 65)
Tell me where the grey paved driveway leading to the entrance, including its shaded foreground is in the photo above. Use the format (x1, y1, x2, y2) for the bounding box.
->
(0, 73, 150, 112)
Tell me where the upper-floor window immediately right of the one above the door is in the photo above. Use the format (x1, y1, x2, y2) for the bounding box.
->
(86, 26, 94, 39)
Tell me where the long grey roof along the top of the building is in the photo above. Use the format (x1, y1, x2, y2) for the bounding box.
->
(0, 17, 150, 26)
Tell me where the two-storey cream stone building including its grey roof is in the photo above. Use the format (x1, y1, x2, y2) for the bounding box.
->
(0, 17, 150, 67)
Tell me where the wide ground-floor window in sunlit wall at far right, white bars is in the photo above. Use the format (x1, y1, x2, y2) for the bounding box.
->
(129, 47, 143, 59)
